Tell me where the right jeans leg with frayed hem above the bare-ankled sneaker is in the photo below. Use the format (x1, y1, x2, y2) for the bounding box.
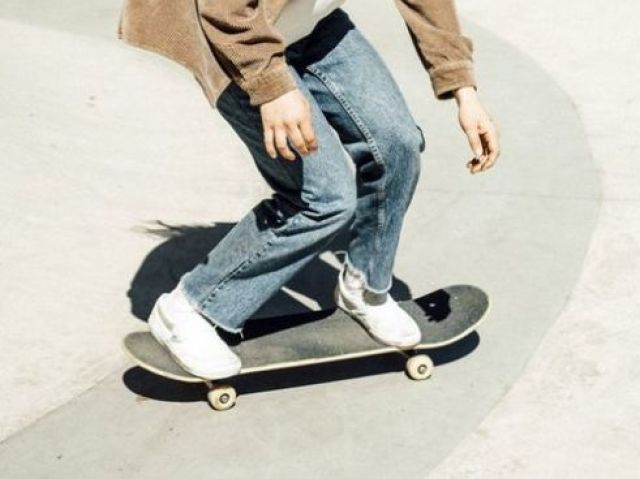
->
(291, 9, 425, 293)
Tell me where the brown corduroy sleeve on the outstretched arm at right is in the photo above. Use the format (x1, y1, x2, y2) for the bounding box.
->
(395, 0, 477, 99)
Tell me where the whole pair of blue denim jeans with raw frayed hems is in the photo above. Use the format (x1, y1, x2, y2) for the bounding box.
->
(179, 8, 425, 333)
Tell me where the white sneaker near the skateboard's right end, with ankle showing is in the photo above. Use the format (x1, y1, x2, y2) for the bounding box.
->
(334, 264, 421, 349)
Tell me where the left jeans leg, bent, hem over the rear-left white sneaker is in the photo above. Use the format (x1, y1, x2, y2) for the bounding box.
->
(179, 63, 356, 332)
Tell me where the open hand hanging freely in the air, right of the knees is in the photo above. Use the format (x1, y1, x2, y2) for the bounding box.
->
(454, 86, 500, 174)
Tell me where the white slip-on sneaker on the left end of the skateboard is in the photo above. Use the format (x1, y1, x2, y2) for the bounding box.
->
(149, 288, 241, 379)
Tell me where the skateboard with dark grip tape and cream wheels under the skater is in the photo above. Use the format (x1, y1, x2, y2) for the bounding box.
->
(123, 285, 490, 411)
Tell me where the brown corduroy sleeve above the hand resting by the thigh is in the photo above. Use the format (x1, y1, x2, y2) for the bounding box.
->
(198, 0, 297, 105)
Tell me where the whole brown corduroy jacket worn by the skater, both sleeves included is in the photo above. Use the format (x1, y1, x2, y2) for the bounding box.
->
(117, 0, 476, 108)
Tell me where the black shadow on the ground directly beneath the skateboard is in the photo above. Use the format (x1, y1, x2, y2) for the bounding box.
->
(122, 332, 480, 402)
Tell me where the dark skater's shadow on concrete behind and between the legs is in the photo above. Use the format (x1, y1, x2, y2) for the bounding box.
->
(127, 220, 411, 321)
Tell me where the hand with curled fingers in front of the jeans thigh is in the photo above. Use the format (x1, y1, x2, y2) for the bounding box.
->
(260, 88, 318, 161)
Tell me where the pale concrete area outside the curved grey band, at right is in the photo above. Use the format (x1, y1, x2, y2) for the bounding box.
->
(429, 0, 640, 479)
